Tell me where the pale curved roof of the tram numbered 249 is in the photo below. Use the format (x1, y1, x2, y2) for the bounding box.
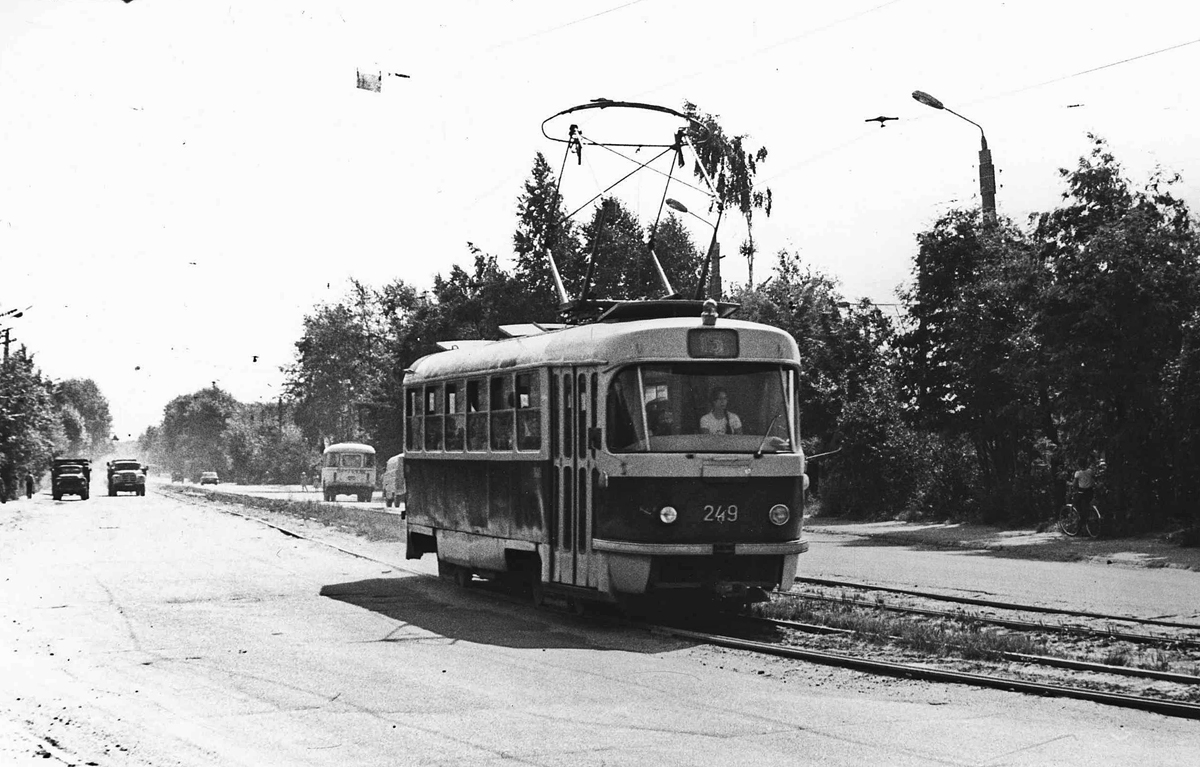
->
(406, 317, 799, 382)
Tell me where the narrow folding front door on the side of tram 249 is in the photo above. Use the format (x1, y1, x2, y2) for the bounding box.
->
(550, 367, 599, 588)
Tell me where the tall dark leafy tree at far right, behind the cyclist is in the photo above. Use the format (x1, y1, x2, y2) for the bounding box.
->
(1034, 134, 1200, 526)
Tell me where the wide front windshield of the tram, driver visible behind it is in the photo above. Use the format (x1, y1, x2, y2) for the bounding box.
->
(607, 362, 796, 453)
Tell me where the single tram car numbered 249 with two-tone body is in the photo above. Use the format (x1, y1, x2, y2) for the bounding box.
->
(403, 299, 808, 601)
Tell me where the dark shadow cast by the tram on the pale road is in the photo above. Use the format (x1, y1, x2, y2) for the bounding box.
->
(320, 576, 657, 653)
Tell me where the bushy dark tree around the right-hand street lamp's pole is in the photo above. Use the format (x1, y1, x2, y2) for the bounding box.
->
(898, 210, 1055, 519)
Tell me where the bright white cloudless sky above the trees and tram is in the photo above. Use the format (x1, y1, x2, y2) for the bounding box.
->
(0, 0, 1200, 439)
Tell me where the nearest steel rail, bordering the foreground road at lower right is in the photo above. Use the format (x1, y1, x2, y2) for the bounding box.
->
(647, 625, 1200, 719)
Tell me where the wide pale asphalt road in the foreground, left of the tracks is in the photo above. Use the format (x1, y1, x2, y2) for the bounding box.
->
(0, 490, 1200, 767)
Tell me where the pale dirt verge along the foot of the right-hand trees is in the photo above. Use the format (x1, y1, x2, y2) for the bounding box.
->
(805, 516, 1200, 571)
